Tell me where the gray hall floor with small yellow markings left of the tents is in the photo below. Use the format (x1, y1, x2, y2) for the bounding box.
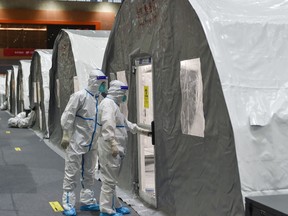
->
(0, 111, 138, 216)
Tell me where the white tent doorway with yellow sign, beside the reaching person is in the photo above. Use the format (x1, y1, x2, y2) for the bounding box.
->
(134, 58, 156, 207)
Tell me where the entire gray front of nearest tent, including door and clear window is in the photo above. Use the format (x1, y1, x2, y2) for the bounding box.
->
(102, 0, 244, 216)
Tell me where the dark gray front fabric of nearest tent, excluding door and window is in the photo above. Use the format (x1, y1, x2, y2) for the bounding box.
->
(103, 0, 244, 216)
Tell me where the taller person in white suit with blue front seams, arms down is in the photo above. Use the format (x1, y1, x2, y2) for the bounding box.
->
(61, 70, 107, 216)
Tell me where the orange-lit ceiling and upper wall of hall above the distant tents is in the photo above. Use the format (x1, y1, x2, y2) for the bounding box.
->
(0, 0, 121, 73)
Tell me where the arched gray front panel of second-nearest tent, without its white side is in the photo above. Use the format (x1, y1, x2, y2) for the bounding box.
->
(48, 30, 76, 145)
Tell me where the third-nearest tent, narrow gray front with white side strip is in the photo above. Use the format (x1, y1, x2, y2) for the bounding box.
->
(29, 49, 52, 138)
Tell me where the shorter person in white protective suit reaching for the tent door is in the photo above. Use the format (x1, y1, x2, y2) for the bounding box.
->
(97, 80, 149, 216)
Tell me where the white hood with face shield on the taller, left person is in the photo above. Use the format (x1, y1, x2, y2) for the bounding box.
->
(87, 69, 107, 95)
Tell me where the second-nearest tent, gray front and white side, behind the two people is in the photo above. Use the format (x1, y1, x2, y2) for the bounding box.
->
(48, 30, 110, 145)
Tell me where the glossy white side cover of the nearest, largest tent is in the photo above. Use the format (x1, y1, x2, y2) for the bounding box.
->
(190, 0, 288, 196)
